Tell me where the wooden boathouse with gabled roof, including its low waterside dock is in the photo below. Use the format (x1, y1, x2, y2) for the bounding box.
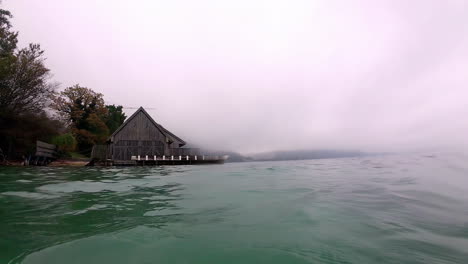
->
(91, 107, 226, 165)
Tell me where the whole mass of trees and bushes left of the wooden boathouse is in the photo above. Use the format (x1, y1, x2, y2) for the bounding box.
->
(0, 7, 126, 157)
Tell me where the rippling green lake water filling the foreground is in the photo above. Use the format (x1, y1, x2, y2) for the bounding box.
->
(0, 154, 468, 264)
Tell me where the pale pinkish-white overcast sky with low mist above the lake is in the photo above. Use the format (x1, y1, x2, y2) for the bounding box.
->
(2, 0, 468, 153)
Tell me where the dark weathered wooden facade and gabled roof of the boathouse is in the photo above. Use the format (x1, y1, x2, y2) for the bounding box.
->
(102, 107, 198, 161)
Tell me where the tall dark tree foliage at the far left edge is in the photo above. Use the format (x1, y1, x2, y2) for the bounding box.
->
(0, 9, 63, 159)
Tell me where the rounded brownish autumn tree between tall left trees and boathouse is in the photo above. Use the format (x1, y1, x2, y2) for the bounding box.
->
(53, 84, 109, 152)
